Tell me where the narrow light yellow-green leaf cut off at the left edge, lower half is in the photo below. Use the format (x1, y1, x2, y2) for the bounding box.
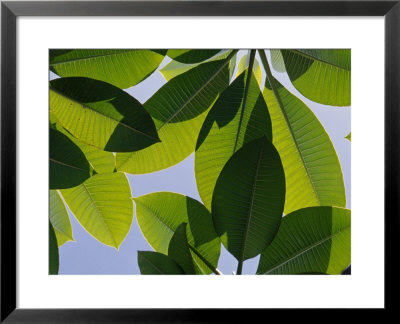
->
(49, 190, 74, 246)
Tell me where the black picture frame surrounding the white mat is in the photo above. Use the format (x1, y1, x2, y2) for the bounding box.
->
(0, 0, 400, 323)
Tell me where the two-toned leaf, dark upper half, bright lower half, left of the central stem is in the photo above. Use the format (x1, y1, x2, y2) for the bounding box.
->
(116, 52, 234, 174)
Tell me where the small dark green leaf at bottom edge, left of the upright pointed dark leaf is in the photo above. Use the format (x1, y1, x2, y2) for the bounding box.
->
(138, 251, 184, 275)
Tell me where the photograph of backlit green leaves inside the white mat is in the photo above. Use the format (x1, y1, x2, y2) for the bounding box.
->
(48, 48, 351, 275)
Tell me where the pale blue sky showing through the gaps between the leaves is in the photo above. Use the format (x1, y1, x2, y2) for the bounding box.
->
(50, 51, 351, 275)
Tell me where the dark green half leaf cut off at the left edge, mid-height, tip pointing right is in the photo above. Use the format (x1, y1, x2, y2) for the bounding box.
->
(49, 128, 90, 189)
